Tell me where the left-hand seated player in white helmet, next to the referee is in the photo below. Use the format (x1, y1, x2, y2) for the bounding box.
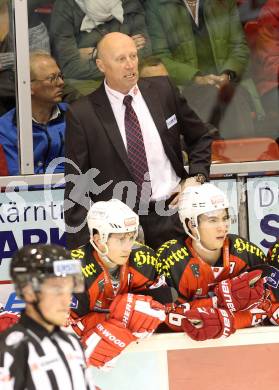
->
(71, 199, 165, 367)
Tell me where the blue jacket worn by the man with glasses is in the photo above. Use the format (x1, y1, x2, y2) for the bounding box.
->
(0, 103, 68, 175)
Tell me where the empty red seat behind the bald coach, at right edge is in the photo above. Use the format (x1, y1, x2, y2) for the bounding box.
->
(212, 137, 279, 164)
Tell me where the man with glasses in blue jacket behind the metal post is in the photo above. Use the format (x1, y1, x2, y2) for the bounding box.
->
(0, 51, 67, 175)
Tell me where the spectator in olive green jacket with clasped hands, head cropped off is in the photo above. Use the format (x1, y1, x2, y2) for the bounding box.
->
(145, 0, 263, 138)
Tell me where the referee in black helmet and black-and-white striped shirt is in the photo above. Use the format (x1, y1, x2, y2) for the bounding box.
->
(0, 244, 98, 390)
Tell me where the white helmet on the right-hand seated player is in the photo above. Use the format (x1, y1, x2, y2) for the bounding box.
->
(178, 183, 229, 238)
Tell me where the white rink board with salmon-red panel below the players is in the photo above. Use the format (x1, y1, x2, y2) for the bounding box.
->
(91, 326, 279, 390)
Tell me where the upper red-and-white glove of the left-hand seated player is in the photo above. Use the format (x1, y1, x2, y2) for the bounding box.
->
(110, 294, 166, 338)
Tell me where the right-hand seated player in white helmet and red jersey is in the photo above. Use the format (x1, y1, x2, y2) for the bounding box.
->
(157, 183, 265, 340)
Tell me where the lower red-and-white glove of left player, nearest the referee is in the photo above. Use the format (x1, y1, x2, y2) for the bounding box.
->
(81, 319, 136, 367)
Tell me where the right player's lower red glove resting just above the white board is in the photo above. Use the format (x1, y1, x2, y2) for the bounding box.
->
(182, 307, 235, 341)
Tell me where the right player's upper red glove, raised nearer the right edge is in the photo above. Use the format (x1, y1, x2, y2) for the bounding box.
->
(214, 270, 264, 312)
